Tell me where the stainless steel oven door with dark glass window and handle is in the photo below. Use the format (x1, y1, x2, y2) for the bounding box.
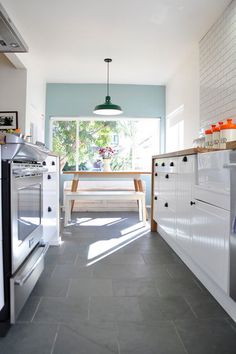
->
(11, 173, 43, 274)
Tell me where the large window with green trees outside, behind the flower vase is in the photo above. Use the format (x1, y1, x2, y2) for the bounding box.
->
(50, 117, 160, 171)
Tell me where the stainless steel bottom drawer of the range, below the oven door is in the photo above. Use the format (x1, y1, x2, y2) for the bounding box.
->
(10, 243, 49, 323)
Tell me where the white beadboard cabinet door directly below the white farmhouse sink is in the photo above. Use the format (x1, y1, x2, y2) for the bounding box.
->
(192, 200, 230, 293)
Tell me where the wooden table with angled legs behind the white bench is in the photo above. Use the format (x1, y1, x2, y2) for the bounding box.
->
(63, 171, 151, 214)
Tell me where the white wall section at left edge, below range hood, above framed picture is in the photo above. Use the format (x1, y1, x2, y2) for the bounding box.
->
(0, 54, 27, 132)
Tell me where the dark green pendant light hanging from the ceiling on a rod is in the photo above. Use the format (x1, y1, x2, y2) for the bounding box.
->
(93, 58, 123, 116)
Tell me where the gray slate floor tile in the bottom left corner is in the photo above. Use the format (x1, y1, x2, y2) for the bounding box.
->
(0, 323, 57, 354)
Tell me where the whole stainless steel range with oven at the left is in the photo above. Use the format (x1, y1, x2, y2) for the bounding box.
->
(0, 135, 48, 334)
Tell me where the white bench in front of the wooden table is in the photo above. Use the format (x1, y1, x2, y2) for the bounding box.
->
(64, 191, 146, 226)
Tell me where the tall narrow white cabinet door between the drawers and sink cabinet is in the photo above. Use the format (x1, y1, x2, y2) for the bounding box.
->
(176, 155, 196, 255)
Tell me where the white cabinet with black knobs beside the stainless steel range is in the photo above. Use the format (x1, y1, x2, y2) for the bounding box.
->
(43, 156, 60, 245)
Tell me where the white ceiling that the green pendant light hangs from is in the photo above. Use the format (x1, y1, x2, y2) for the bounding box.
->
(0, 0, 230, 84)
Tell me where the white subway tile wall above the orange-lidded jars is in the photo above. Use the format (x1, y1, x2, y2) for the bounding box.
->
(199, 0, 236, 128)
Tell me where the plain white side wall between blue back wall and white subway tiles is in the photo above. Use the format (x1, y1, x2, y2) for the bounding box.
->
(166, 45, 199, 151)
